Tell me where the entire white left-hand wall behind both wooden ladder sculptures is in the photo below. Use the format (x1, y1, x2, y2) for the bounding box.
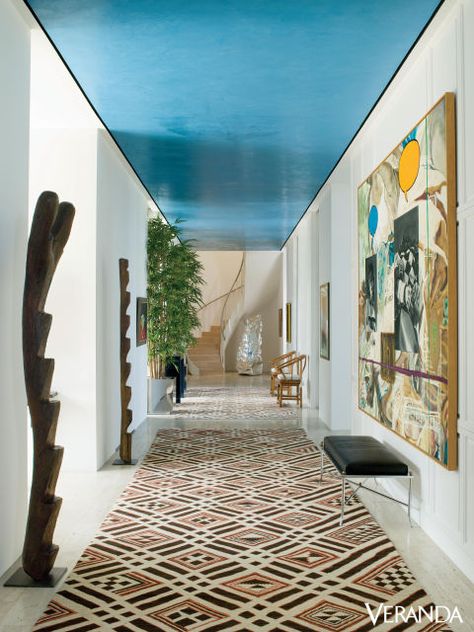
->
(0, 0, 148, 575)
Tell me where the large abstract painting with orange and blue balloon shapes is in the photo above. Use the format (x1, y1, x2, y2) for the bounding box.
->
(358, 93, 457, 469)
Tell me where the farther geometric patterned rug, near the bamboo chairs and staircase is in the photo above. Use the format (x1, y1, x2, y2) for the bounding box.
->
(171, 381, 301, 421)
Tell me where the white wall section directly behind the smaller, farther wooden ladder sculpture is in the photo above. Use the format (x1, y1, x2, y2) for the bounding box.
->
(96, 131, 149, 467)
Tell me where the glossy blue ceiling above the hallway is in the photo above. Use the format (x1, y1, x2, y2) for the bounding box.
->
(28, 0, 438, 250)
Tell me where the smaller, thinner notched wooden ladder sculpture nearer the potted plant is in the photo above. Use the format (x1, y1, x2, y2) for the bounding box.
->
(114, 259, 136, 465)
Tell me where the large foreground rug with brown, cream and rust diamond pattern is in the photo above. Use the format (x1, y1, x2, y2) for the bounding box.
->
(34, 429, 448, 632)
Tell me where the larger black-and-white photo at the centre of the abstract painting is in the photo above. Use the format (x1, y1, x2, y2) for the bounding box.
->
(394, 206, 420, 353)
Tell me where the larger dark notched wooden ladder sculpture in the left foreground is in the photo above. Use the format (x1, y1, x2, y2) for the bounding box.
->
(6, 191, 75, 586)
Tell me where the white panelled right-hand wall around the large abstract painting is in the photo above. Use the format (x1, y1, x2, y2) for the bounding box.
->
(287, 0, 474, 579)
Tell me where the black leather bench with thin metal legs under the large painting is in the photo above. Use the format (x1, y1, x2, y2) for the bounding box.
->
(320, 435, 413, 525)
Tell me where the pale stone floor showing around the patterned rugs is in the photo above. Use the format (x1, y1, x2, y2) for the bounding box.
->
(0, 374, 474, 632)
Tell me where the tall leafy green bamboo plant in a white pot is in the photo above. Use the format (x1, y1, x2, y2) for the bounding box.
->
(147, 217, 203, 412)
